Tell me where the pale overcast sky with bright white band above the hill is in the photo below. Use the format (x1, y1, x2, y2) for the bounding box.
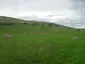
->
(0, 0, 85, 27)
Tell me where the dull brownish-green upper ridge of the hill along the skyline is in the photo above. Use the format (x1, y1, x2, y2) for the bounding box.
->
(0, 16, 74, 28)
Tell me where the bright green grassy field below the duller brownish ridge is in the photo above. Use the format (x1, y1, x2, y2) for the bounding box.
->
(0, 19, 85, 64)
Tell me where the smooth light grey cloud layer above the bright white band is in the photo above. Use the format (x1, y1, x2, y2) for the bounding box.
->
(0, 0, 71, 11)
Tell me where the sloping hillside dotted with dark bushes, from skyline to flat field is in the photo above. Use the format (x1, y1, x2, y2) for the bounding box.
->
(0, 16, 74, 33)
